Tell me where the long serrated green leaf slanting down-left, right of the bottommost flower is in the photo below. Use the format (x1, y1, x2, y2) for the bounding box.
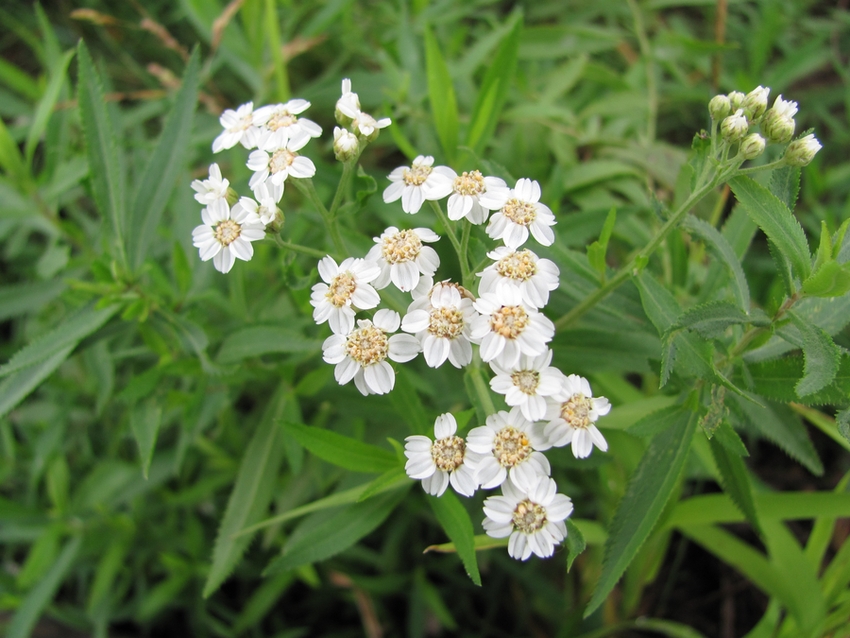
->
(584, 409, 697, 618)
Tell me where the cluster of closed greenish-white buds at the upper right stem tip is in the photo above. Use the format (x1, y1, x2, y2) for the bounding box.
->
(708, 86, 821, 166)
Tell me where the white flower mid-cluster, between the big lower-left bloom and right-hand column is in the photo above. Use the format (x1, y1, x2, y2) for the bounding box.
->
(401, 277, 478, 368)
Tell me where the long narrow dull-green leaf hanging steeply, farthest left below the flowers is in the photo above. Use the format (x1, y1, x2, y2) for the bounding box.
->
(203, 387, 290, 598)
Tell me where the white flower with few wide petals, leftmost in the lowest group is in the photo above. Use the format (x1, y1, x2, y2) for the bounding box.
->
(404, 412, 479, 496)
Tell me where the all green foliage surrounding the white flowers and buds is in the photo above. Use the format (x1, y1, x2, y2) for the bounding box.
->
(0, 0, 850, 638)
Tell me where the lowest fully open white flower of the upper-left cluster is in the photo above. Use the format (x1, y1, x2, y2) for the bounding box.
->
(192, 202, 266, 272)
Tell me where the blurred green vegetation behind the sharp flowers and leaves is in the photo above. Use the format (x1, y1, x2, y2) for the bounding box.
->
(0, 0, 850, 638)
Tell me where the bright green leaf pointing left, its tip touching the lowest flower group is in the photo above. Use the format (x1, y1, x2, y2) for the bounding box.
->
(284, 423, 398, 473)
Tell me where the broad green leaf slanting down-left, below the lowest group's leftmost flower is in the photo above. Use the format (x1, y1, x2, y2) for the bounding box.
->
(263, 489, 407, 576)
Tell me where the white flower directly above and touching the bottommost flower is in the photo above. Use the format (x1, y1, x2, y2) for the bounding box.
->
(466, 408, 550, 490)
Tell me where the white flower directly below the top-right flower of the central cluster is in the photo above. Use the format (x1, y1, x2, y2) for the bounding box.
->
(478, 246, 561, 308)
